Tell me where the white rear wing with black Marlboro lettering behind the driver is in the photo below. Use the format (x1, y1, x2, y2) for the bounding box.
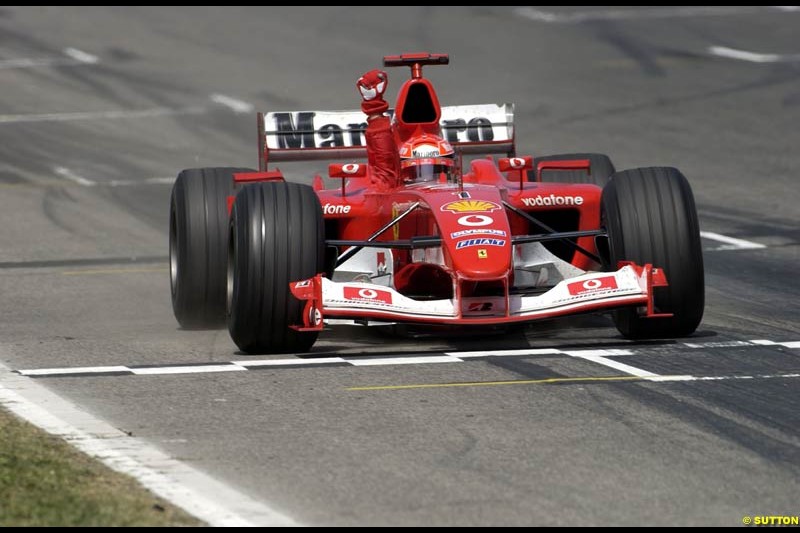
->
(258, 104, 514, 171)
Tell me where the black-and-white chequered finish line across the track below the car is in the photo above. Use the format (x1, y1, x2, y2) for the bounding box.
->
(14, 339, 800, 381)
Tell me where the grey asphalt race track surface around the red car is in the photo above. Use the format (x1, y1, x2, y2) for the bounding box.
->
(0, 7, 800, 525)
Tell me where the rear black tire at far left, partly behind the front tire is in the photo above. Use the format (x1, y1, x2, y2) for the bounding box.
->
(169, 168, 253, 329)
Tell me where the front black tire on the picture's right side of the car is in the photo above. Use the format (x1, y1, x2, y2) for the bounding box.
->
(602, 167, 705, 339)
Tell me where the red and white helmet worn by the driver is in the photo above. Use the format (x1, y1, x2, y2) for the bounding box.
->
(400, 133, 455, 183)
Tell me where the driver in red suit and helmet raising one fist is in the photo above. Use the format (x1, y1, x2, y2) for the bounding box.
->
(356, 69, 455, 190)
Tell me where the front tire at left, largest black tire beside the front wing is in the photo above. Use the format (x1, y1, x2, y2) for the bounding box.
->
(227, 182, 325, 354)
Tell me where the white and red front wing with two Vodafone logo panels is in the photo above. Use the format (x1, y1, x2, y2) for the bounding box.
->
(289, 262, 671, 331)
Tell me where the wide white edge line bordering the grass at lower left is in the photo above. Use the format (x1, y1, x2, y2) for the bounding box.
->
(0, 358, 300, 527)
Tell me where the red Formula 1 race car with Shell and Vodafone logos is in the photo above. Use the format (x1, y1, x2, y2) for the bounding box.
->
(169, 53, 704, 353)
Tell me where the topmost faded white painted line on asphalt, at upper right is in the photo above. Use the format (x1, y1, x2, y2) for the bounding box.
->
(514, 6, 769, 24)
